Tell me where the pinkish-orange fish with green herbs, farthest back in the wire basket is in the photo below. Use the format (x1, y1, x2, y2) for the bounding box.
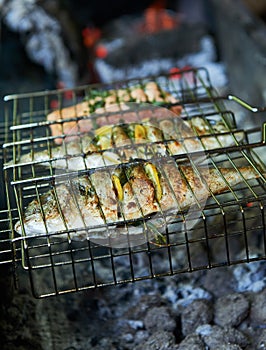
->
(47, 81, 182, 144)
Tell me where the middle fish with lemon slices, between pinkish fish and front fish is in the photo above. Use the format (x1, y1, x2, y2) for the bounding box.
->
(11, 117, 244, 171)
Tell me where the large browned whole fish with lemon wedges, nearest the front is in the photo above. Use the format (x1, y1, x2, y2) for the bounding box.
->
(15, 159, 260, 240)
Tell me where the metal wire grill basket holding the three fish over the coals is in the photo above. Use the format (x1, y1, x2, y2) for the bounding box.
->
(4, 69, 266, 297)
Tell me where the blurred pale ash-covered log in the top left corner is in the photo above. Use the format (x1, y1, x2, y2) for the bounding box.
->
(0, 0, 78, 88)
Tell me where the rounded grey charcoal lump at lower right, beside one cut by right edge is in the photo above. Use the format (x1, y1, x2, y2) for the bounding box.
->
(214, 293, 249, 326)
